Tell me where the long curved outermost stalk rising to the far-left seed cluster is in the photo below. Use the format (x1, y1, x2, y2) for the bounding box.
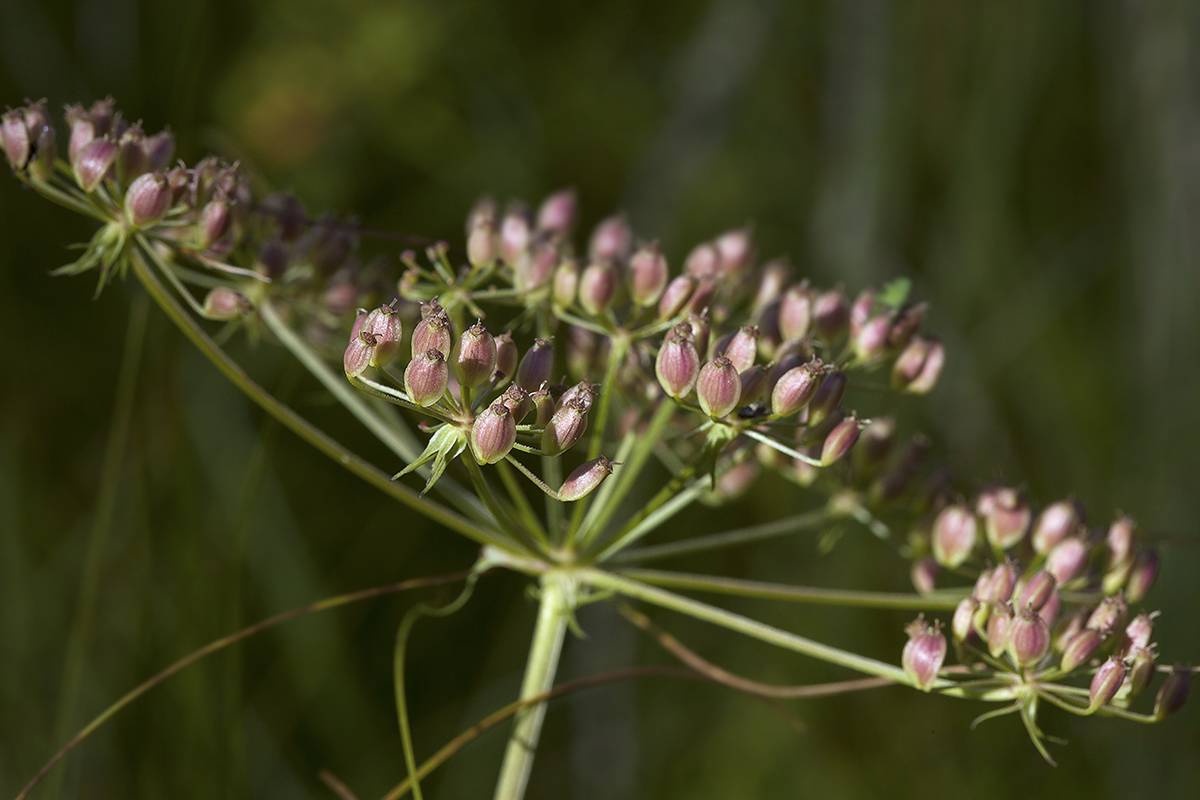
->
(124, 249, 499, 549)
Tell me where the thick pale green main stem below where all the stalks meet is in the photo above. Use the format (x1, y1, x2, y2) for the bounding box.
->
(493, 573, 575, 800)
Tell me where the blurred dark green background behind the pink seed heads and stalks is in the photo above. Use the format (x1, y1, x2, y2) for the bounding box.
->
(0, 0, 1200, 800)
